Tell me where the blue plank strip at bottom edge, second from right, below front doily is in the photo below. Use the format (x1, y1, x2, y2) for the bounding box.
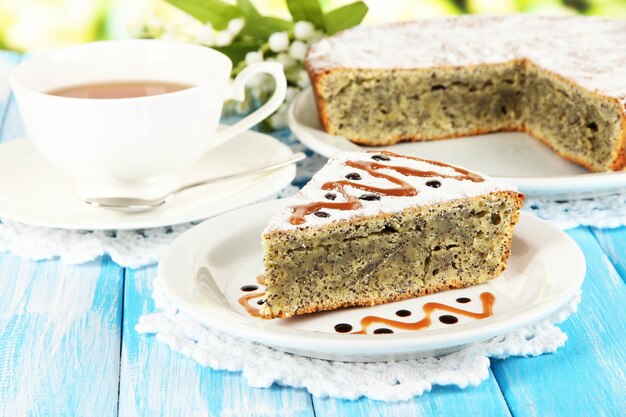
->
(313, 372, 511, 417)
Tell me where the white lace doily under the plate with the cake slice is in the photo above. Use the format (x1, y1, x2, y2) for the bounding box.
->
(135, 280, 580, 401)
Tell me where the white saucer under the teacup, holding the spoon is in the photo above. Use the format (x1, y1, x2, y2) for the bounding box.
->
(0, 132, 296, 230)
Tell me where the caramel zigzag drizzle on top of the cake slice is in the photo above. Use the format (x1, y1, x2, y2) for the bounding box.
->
(289, 151, 484, 225)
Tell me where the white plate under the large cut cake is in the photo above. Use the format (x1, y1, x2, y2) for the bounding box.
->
(288, 89, 626, 198)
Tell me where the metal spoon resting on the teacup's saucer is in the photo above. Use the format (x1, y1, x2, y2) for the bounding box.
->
(84, 152, 306, 212)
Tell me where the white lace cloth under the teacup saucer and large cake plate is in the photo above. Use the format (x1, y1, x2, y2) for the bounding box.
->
(0, 130, 626, 268)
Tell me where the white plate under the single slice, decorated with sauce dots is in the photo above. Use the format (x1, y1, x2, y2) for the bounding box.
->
(158, 200, 585, 361)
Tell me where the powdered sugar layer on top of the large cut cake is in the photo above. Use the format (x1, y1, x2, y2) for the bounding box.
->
(307, 14, 626, 103)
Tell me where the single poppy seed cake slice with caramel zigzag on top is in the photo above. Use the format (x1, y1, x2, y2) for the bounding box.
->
(260, 151, 524, 318)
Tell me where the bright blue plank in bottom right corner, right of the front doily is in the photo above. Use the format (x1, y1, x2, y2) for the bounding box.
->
(492, 228, 626, 417)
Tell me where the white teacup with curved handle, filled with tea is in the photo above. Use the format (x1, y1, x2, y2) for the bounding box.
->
(10, 40, 287, 196)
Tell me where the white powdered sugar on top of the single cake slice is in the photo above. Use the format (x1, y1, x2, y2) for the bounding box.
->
(265, 152, 516, 232)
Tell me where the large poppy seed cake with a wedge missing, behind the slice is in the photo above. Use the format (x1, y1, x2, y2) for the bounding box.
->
(306, 15, 626, 171)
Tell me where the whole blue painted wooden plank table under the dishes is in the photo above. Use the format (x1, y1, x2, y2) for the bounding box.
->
(0, 52, 626, 417)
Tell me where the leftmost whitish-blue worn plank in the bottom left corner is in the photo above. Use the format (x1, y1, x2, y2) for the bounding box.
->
(0, 255, 123, 416)
